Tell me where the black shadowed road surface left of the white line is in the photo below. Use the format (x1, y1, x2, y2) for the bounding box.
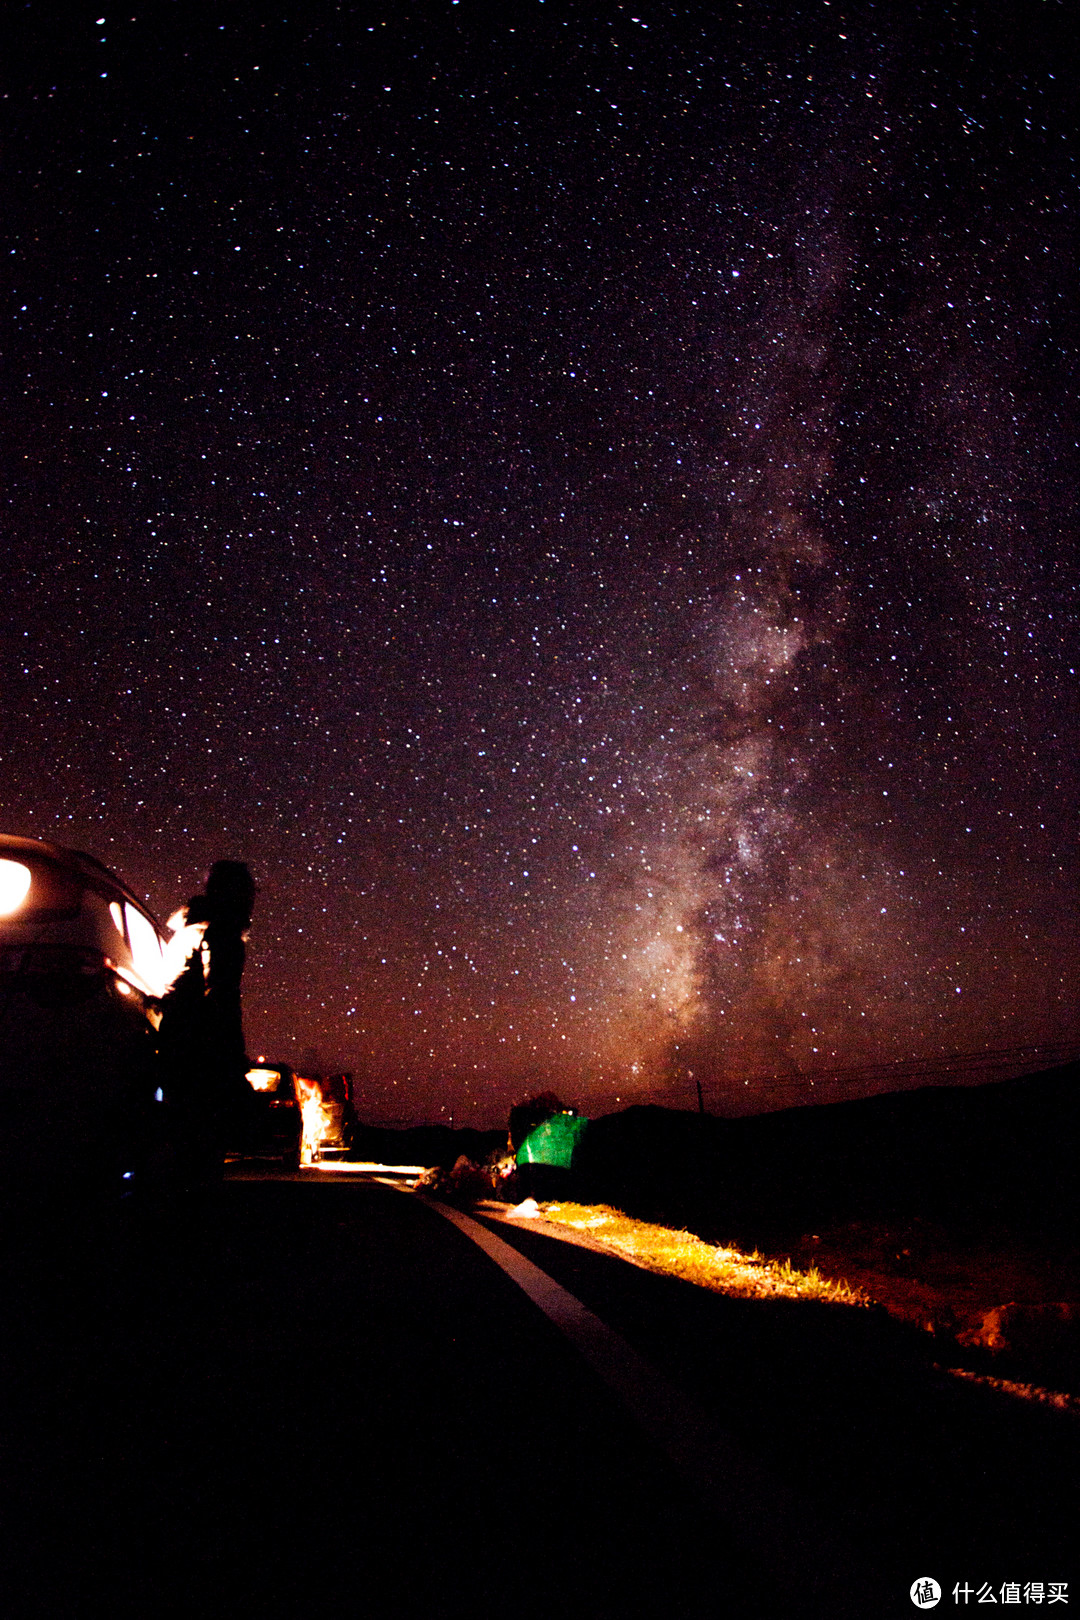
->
(3, 1181, 769, 1617)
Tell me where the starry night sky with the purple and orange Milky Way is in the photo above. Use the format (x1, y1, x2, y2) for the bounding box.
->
(0, 0, 1080, 1124)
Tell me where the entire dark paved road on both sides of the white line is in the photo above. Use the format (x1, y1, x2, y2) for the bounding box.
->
(0, 1178, 1077, 1620)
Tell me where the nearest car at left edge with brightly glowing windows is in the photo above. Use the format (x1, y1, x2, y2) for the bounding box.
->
(0, 834, 167, 1196)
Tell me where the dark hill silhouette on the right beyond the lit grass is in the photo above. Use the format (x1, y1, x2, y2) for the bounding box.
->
(576, 1063, 1080, 1247)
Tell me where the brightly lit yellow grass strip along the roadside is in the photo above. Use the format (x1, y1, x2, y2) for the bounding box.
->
(541, 1204, 870, 1306)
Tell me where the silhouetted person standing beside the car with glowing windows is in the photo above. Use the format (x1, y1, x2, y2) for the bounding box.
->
(157, 860, 256, 1178)
